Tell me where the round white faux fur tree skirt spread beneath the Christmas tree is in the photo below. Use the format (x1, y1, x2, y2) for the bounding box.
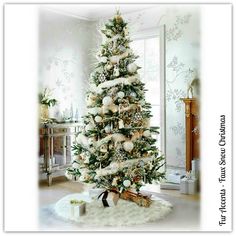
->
(54, 193, 172, 226)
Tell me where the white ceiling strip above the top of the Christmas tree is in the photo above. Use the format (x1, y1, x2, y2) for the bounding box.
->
(43, 3, 156, 21)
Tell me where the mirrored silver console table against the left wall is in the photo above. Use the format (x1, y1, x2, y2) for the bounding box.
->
(39, 123, 81, 186)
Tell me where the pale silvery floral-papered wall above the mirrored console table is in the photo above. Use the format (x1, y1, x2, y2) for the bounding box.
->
(39, 10, 95, 118)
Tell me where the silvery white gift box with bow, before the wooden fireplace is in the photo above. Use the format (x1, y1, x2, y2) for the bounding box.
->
(180, 176, 197, 194)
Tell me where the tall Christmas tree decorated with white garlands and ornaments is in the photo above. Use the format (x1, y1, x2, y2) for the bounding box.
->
(66, 12, 164, 193)
